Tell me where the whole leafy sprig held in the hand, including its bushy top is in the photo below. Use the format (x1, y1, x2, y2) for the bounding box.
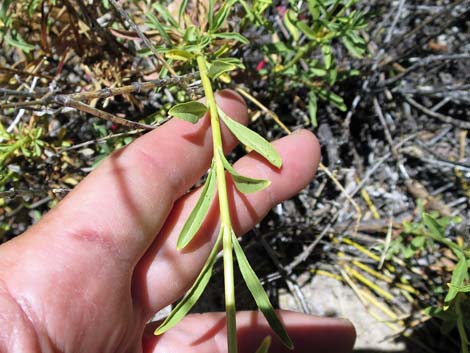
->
(148, 1, 293, 353)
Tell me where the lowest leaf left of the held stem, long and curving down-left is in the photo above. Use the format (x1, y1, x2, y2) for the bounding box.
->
(154, 233, 222, 335)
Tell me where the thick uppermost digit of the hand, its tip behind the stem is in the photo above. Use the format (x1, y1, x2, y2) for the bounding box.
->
(25, 91, 247, 264)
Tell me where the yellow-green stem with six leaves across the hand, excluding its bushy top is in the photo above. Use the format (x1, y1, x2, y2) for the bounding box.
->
(155, 55, 293, 353)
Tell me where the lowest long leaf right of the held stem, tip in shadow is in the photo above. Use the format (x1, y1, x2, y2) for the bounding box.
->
(232, 231, 294, 349)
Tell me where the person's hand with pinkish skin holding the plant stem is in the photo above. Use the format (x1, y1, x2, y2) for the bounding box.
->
(0, 91, 355, 353)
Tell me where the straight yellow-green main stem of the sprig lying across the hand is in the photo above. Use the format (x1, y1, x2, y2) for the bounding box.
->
(197, 55, 238, 353)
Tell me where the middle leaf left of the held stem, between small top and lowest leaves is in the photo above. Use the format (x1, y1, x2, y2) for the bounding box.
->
(176, 166, 217, 250)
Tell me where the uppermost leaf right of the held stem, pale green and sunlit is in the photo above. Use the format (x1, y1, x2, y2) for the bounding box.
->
(217, 108, 282, 168)
